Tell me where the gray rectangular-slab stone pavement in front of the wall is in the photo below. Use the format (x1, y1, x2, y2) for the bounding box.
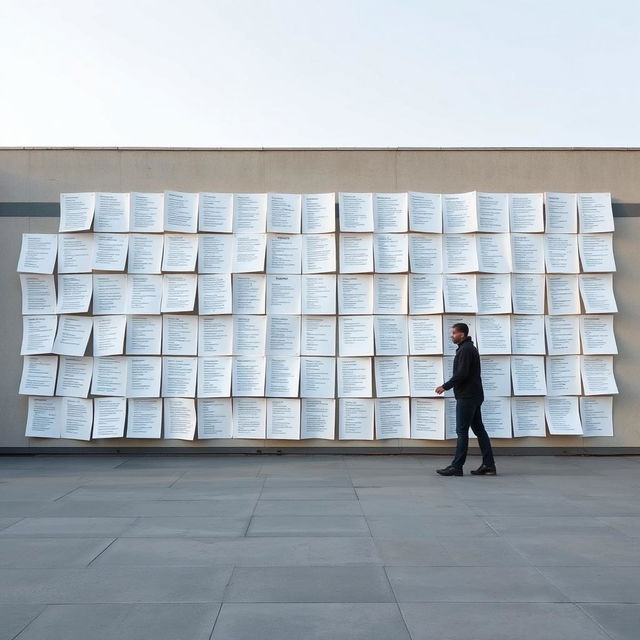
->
(0, 454, 640, 640)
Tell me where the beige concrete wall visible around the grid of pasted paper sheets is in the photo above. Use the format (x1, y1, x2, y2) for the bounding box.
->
(0, 149, 640, 453)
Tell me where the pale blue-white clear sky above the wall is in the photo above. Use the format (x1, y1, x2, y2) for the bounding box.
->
(0, 0, 640, 147)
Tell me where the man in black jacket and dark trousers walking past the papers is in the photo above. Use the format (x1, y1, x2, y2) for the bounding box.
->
(436, 322, 496, 476)
